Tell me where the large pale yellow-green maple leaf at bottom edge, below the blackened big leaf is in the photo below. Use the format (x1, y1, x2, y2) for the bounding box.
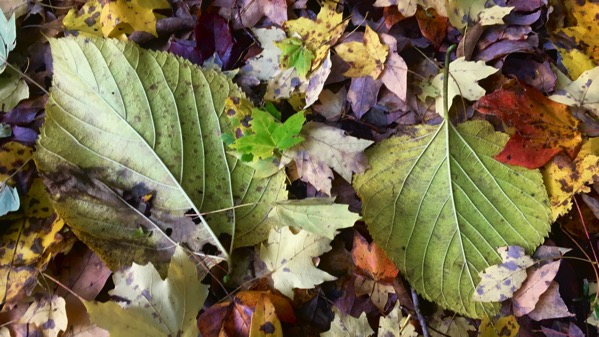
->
(83, 246, 208, 337)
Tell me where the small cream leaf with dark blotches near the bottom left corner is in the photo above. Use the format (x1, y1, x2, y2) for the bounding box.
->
(16, 295, 67, 337)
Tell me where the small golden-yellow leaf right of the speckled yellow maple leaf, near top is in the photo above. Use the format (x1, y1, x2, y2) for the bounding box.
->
(335, 26, 389, 79)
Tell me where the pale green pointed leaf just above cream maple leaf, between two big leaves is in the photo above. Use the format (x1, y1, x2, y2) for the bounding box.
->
(268, 198, 360, 240)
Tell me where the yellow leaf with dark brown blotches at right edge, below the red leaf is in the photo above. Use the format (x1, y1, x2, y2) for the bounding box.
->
(542, 138, 599, 221)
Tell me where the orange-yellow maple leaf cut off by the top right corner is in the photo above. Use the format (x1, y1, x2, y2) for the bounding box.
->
(557, 1, 599, 63)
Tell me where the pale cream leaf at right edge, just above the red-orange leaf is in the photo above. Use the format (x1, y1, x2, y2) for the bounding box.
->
(549, 66, 599, 117)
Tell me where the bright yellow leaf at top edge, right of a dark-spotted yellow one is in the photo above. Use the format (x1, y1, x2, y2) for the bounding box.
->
(101, 0, 170, 37)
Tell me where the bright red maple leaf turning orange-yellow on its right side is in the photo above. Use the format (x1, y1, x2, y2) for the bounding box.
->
(474, 81, 582, 169)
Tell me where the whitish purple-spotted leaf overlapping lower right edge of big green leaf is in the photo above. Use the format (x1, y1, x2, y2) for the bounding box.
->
(473, 246, 536, 302)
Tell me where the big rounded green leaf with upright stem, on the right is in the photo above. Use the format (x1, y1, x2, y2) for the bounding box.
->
(354, 121, 550, 317)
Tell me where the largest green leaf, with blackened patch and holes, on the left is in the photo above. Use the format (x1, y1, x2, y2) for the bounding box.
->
(35, 38, 285, 269)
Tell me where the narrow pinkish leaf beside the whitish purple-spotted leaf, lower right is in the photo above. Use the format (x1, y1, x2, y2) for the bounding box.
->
(512, 260, 561, 317)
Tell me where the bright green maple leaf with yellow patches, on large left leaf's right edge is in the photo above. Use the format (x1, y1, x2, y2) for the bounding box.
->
(229, 108, 306, 161)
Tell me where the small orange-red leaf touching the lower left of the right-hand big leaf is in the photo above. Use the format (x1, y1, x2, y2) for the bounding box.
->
(352, 232, 399, 283)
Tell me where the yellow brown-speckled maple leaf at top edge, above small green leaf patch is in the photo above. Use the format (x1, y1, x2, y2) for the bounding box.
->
(284, 1, 347, 70)
